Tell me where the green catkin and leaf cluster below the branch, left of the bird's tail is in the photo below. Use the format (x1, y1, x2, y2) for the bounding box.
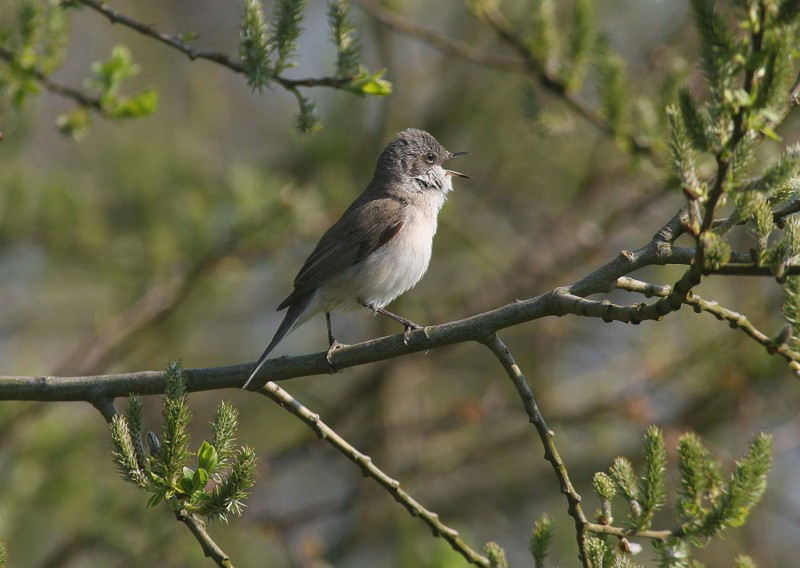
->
(111, 362, 256, 522)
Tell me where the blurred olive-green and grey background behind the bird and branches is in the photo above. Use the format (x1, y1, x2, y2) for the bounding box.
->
(0, 0, 800, 567)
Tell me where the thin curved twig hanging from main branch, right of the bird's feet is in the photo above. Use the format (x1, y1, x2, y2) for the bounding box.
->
(481, 334, 591, 568)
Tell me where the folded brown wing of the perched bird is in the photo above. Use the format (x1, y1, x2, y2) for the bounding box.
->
(278, 193, 406, 310)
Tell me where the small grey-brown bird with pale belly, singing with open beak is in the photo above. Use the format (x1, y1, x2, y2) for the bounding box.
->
(242, 128, 469, 389)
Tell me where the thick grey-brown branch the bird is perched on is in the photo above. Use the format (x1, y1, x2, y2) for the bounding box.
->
(0, 209, 800, 404)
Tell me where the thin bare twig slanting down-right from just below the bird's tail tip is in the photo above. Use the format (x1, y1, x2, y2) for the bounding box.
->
(258, 381, 489, 567)
